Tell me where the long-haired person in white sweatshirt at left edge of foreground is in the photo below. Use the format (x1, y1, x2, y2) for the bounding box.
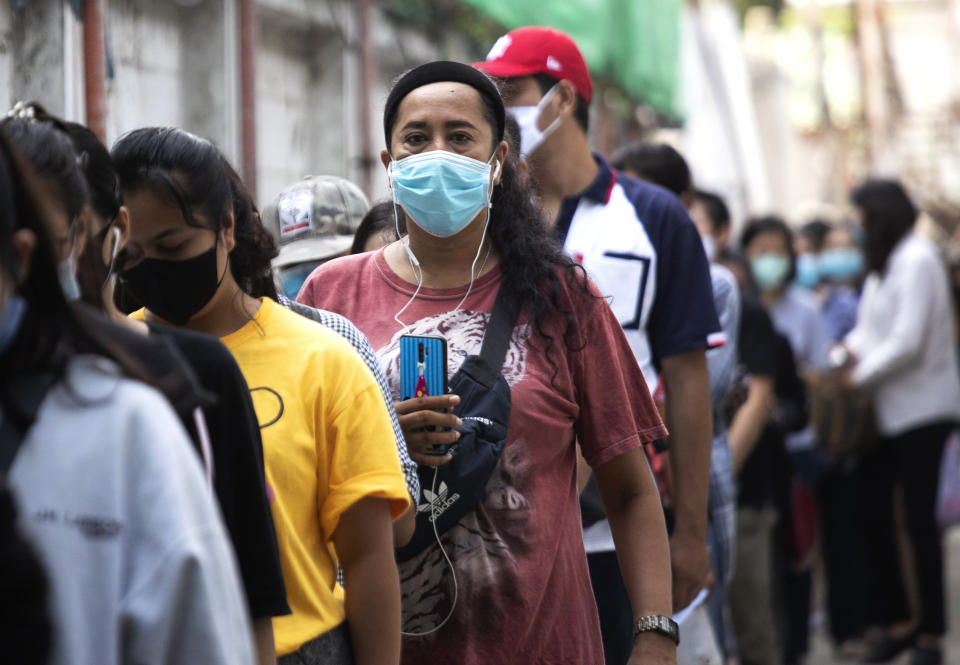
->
(0, 123, 254, 665)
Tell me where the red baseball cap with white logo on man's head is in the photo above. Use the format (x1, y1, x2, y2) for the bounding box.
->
(473, 25, 593, 104)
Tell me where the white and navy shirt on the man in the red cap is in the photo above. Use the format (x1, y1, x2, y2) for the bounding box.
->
(555, 155, 725, 392)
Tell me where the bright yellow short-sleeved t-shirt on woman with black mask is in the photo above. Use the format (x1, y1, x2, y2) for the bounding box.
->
(133, 298, 410, 656)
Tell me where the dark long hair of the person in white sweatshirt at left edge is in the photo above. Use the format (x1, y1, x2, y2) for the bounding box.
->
(0, 132, 150, 431)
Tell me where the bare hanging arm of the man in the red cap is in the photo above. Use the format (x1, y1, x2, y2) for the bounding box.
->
(660, 349, 713, 611)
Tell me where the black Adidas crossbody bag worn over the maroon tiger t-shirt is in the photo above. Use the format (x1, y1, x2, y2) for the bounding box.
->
(397, 285, 520, 561)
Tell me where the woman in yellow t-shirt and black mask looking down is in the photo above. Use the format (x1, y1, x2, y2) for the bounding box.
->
(112, 128, 409, 665)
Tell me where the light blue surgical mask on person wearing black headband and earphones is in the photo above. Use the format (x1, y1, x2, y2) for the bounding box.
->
(389, 150, 500, 238)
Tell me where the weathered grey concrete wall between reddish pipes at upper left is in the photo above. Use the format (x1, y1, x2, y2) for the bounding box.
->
(0, 0, 474, 205)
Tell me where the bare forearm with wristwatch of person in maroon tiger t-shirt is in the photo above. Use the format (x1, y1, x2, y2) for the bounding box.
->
(594, 448, 677, 665)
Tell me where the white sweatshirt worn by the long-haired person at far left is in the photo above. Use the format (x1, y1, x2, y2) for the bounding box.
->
(9, 356, 254, 665)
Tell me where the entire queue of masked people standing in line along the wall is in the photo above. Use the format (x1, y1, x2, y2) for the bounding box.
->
(0, 27, 960, 665)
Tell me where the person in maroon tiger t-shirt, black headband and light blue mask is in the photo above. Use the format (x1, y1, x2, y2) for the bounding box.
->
(299, 62, 675, 664)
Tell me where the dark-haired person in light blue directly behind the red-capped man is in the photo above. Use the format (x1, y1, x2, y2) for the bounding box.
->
(613, 143, 740, 665)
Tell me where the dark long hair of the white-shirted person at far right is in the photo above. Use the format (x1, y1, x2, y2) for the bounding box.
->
(850, 178, 917, 273)
